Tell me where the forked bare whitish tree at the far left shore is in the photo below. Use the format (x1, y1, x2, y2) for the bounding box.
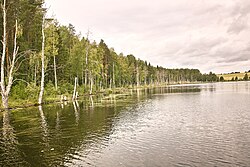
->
(1, 0, 18, 109)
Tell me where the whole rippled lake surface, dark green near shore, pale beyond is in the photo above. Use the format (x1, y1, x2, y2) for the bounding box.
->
(0, 82, 250, 167)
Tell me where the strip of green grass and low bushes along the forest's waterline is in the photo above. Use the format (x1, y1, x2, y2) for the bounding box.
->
(0, 82, 211, 110)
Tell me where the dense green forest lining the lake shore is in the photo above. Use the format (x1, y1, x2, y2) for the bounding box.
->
(0, 0, 219, 108)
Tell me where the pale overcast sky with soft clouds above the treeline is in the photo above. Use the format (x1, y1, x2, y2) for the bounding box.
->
(45, 0, 250, 74)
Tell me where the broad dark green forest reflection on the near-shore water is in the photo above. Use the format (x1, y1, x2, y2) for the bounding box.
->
(0, 97, 135, 166)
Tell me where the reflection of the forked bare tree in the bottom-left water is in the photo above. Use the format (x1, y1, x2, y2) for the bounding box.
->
(0, 111, 27, 166)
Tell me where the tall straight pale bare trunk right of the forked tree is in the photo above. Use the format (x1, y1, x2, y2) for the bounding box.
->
(38, 16, 45, 104)
